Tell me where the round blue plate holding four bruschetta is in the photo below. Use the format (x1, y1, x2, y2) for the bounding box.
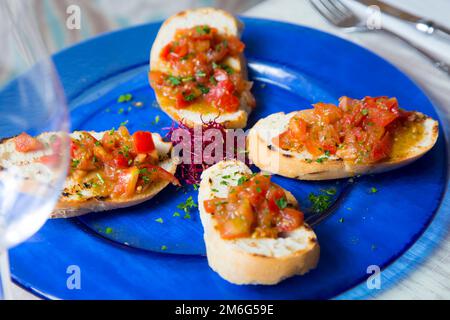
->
(6, 19, 447, 299)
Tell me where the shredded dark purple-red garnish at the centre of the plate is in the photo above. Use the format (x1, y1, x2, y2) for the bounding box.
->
(163, 120, 248, 185)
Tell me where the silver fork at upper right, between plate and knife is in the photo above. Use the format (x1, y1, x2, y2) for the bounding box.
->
(309, 0, 450, 76)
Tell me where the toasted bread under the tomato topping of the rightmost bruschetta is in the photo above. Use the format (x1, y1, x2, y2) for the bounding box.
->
(248, 110, 439, 180)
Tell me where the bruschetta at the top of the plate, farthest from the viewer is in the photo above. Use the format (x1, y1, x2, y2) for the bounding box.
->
(149, 8, 255, 128)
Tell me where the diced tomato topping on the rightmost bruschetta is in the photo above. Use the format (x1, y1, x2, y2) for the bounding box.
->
(273, 97, 409, 163)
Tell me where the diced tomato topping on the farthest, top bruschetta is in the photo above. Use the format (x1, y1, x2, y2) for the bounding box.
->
(149, 25, 255, 112)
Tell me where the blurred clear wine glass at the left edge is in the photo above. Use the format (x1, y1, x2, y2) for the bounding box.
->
(0, 0, 69, 299)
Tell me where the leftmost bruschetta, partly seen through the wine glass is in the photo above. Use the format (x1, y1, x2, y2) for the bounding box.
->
(0, 126, 178, 218)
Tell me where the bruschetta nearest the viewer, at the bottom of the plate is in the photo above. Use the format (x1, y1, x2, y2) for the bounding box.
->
(198, 160, 320, 285)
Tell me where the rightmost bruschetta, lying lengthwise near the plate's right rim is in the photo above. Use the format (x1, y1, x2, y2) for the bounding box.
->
(248, 97, 439, 180)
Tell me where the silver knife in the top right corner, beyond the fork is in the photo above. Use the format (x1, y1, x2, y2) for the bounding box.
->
(357, 0, 450, 37)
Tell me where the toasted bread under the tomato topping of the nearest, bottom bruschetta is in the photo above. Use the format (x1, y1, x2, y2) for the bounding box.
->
(198, 160, 320, 285)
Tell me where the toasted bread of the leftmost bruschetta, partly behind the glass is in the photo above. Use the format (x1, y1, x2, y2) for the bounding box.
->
(0, 132, 177, 218)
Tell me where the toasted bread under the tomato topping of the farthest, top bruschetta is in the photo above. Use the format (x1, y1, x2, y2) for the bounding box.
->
(150, 8, 252, 128)
